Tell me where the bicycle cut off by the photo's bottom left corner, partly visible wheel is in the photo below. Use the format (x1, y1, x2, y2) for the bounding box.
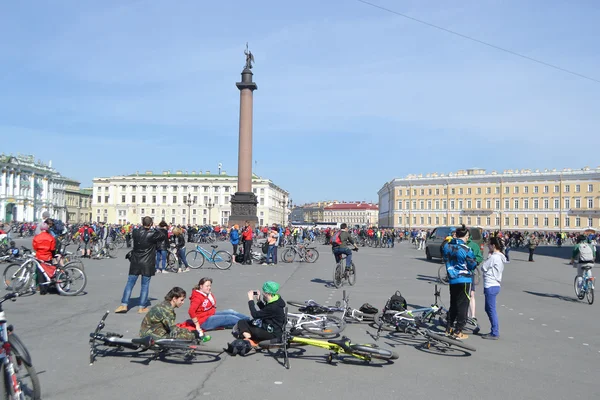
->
(0, 293, 41, 400)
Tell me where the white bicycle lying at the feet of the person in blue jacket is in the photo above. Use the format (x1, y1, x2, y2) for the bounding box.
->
(375, 285, 476, 352)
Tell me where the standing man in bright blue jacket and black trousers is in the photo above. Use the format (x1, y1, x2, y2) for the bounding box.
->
(444, 225, 477, 340)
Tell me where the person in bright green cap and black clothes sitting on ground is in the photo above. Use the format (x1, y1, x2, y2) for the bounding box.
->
(238, 281, 285, 346)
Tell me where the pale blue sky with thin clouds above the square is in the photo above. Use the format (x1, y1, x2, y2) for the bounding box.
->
(0, 0, 600, 204)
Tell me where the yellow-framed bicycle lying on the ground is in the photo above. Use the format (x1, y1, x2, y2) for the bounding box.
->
(258, 307, 398, 369)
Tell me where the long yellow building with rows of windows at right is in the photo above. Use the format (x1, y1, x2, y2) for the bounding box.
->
(378, 167, 600, 231)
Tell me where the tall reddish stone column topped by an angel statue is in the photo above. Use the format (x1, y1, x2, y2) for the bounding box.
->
(229, 43, 258, 228)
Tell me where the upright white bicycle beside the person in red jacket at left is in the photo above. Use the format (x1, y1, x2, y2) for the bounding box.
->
(4, 255, 87, 296)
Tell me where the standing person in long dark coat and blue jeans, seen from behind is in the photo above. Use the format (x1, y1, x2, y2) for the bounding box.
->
(115, 217, 165, 314)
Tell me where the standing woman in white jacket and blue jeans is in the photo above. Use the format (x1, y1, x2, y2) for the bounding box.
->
(481, 237, 506, 340)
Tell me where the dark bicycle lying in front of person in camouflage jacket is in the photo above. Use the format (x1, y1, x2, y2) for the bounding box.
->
(89, 311, 223, 365)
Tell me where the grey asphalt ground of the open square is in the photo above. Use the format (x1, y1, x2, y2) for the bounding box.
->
(2, 239, 600, 399)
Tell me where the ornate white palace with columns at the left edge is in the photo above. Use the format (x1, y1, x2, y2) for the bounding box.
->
(0, 154, 66, 222)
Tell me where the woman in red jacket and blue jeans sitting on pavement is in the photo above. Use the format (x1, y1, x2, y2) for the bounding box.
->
(178, 278, 250, 332)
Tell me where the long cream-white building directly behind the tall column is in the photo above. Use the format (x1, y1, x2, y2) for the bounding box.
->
(92, 171, 289, 225)
